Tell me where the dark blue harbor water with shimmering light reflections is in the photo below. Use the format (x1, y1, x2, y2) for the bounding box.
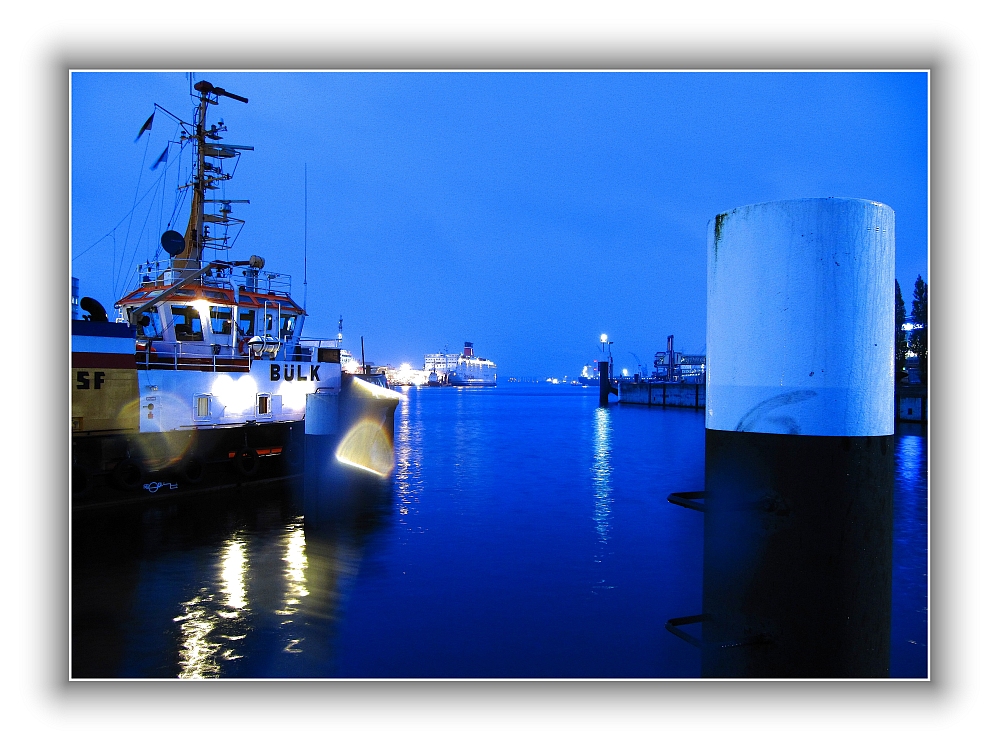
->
(71, 384, 928, 679)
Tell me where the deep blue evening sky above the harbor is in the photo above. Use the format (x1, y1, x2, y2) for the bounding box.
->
(71, 72, 928, 379)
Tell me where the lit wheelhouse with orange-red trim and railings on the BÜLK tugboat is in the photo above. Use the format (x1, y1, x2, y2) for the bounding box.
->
(115, 256, 328, 372)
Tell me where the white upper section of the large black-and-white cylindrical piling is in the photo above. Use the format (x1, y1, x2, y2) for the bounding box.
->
(705, 198, 895, 436)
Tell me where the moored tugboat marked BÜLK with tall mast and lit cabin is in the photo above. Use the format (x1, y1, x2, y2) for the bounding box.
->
(71, 81, 398, 504)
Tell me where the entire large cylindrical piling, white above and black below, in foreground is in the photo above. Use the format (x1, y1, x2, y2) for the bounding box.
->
(702, 198, 895, 677)
